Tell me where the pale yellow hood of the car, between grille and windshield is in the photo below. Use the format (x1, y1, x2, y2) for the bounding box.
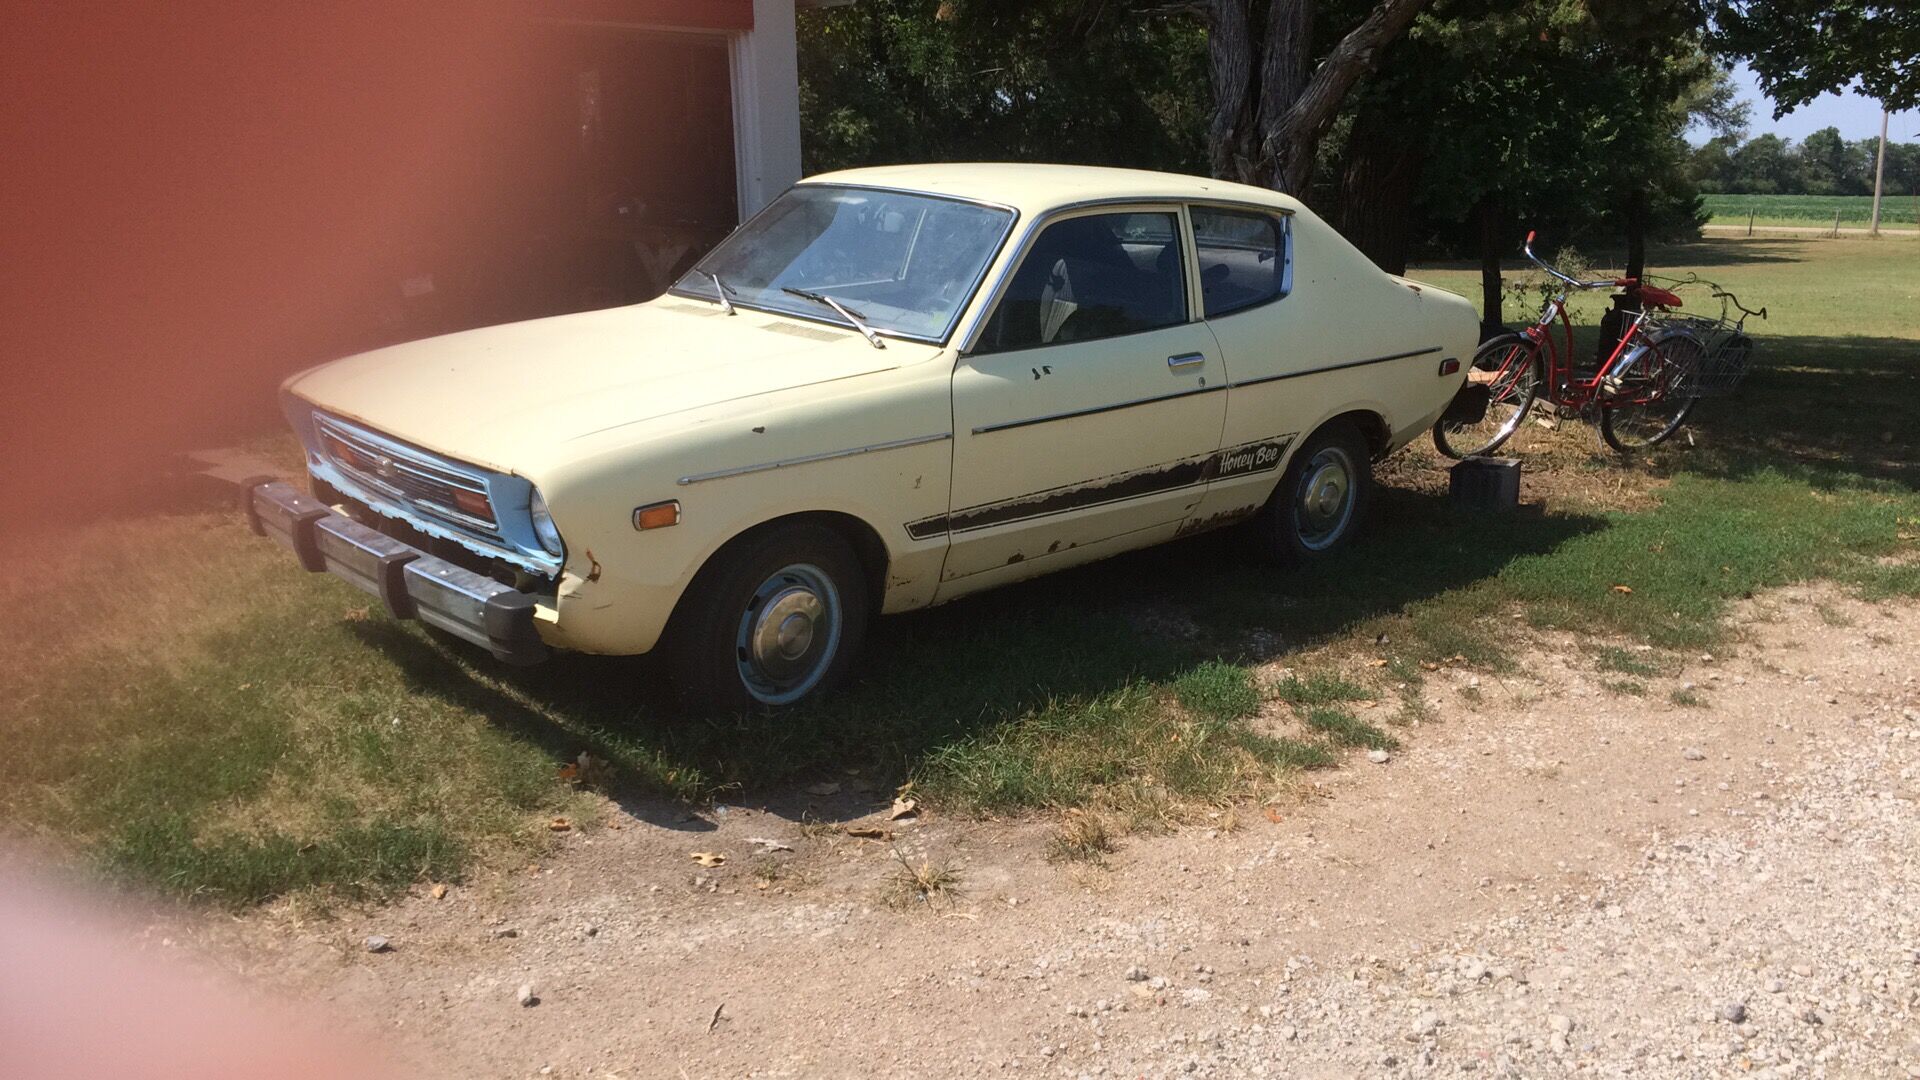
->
(286, 296, 937, 471)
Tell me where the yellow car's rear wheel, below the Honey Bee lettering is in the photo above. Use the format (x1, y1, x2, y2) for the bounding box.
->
(1252, 421, 1373, 565)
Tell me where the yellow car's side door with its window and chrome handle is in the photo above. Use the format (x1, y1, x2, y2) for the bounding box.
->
(933, 204, 1227, 592)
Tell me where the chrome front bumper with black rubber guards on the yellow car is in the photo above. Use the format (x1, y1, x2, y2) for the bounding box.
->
(242, 480, 547, 665)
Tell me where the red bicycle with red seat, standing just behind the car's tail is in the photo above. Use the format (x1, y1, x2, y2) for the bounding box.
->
(1434, 233, 1707, 457)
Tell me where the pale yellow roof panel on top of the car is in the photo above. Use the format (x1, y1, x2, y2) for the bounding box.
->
(801, 161, 1300, 217)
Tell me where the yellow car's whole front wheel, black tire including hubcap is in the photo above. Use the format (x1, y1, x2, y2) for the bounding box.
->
(662, 521, 872, 715)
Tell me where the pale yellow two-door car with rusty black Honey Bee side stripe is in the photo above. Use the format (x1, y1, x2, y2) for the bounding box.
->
(248, 165, 1478, 709)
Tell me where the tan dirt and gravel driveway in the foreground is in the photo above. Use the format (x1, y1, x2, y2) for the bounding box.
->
(146, 588, 1920, 1080)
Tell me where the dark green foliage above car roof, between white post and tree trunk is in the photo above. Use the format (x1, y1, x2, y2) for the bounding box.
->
(799, 0, 1208, 173)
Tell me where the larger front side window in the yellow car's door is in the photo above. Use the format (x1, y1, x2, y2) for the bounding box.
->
(977, 213, 1187, 352)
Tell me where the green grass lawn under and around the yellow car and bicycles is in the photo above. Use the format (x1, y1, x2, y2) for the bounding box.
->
(0, 238, 1920, 903)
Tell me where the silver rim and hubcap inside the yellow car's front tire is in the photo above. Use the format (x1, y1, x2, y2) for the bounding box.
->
(735, 565, 841, 705)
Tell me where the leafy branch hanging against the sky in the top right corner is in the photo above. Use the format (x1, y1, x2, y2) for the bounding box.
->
(1715, 0, 1920, 117)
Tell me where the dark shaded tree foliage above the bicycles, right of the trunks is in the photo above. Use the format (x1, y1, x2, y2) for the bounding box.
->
(1321, 0, 1720, 295)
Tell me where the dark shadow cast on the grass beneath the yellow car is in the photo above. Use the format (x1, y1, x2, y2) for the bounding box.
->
(361, 478, 1603, 814)
